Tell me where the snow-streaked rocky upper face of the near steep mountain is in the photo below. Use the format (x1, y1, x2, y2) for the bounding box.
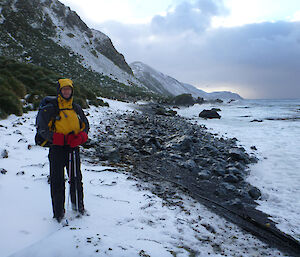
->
(43, 0, 140, 85)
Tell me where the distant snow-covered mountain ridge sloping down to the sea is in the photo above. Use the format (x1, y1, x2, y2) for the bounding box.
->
(130, 62, 242, 99)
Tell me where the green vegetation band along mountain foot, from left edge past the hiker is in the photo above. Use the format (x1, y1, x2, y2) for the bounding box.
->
(0, 56, 169, 118)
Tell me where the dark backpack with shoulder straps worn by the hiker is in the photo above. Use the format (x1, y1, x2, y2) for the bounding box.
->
(34, 96, 81, 147)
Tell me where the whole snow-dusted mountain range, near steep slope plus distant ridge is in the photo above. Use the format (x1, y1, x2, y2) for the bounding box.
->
(0, 0, 240, 99)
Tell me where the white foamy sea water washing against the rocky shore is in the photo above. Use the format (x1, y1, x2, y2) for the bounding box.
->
(175, 99, 300, 241)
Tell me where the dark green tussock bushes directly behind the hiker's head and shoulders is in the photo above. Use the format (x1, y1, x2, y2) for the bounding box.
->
(0, 56, 102, 118)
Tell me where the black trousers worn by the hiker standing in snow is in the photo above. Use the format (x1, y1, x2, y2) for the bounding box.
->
(48, 145, 84, 218)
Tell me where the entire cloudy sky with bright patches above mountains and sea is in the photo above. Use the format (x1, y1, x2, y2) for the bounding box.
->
(60, 0, 300, 98)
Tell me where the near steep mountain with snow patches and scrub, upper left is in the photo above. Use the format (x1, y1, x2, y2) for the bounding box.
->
(0, 0, 143, 87)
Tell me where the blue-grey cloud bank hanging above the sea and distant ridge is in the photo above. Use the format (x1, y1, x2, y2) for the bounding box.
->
(96, 0, 300, 98)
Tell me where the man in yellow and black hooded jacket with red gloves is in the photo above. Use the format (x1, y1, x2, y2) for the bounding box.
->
(37, 79, 89, 222)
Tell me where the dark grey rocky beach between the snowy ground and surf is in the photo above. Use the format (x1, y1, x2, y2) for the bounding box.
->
(86, 104, 300, 256)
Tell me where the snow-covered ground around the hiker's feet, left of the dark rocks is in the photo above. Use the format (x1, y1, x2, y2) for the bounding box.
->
(0, 97, 290, 254)
